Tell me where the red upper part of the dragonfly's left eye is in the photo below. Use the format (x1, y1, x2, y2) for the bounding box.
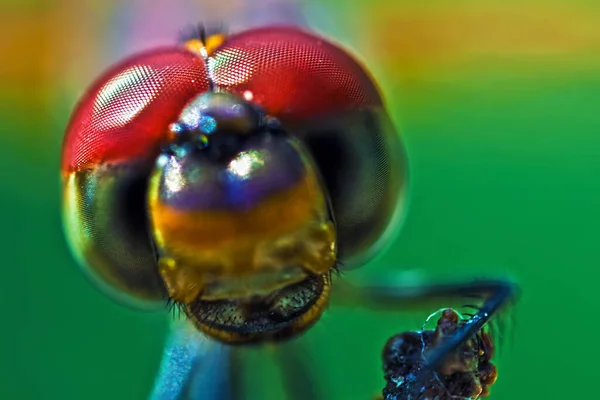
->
(62, 48, 209, 173)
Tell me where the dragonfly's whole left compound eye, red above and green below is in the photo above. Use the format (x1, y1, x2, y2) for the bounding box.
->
(62, 48, 209, 309)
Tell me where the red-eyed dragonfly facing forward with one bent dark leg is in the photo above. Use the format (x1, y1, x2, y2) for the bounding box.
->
(61, 0, 517, 400)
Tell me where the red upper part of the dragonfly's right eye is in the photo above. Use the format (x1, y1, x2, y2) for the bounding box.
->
(210, 27, 381, 119)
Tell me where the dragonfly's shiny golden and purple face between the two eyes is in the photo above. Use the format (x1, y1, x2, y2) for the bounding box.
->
(148, 93, 337, 342)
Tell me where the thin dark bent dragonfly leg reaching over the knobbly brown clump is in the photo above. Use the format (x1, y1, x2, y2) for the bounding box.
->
(334, 274, 519, 368)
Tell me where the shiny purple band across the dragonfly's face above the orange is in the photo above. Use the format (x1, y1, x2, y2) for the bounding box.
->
(161, 138, 307, 211)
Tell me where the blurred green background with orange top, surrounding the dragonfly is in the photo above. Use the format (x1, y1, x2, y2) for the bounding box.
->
(0, 0, 600, 400)
